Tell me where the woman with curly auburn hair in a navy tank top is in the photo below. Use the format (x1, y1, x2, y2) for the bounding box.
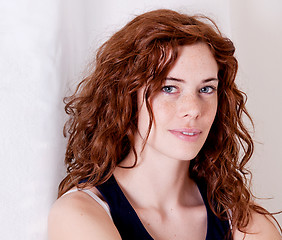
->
(49, 10, 280, 240)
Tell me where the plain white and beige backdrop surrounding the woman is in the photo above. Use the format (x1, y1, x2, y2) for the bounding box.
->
(0, 0, 282, 240)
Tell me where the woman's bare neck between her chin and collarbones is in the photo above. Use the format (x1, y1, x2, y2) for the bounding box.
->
(114, 144, 195, 208)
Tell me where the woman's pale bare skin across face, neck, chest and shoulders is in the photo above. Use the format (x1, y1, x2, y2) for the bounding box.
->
(48, 43, 281, 240)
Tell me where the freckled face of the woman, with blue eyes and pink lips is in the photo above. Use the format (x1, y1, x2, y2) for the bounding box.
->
(137, 43, 218, 160)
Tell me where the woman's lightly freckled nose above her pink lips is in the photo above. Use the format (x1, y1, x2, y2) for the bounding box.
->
(177, 94, 202, 119)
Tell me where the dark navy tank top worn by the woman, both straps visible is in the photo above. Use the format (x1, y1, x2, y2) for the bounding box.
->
(97, 176, 232, 240)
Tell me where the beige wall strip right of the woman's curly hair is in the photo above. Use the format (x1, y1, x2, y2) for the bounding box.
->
(230, 0, 282, 224)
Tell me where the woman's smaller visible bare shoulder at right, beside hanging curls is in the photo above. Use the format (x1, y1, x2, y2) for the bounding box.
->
(234, 212, 282, 240)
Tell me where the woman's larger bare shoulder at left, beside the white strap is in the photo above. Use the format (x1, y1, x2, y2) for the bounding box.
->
(48, 191, 121, 240)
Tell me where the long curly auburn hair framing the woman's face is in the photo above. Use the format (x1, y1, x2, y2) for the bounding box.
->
(58, 9, 278, 230)
